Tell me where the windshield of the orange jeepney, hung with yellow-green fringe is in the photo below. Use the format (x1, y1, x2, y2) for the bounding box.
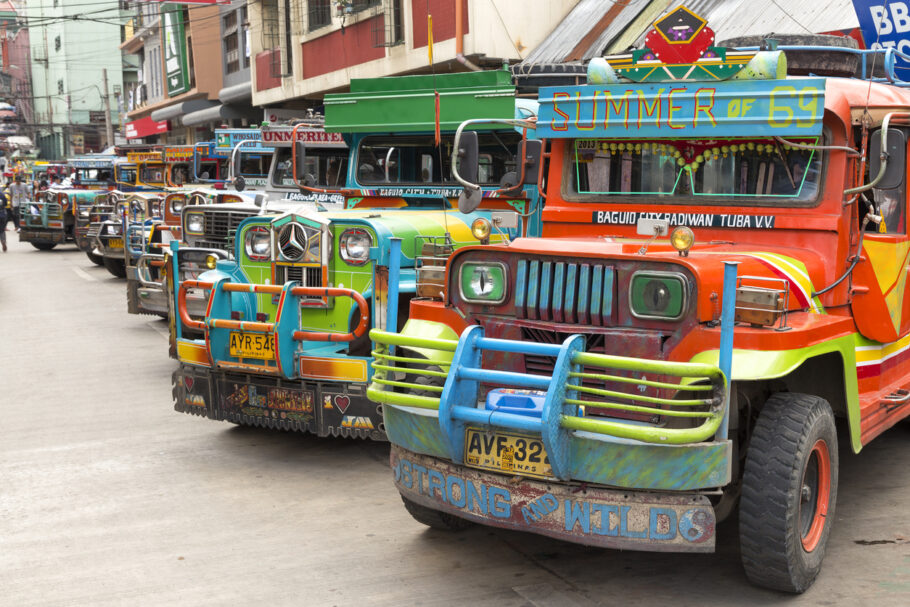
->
(571, 138, 822, 202)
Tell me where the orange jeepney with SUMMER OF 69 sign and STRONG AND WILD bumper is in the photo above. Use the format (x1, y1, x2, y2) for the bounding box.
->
(366, 8, 910, 592)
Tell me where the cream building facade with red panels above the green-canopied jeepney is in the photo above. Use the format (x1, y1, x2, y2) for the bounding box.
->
(249, 0, 577, 108)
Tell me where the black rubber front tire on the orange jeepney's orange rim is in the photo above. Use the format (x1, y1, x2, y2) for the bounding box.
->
(739, 392, 838, 593)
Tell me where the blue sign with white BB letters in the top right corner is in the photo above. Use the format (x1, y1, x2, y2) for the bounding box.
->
(853, 0, 910, 79)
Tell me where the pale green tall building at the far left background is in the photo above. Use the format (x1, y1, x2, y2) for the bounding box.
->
(27, 0, 123, 159)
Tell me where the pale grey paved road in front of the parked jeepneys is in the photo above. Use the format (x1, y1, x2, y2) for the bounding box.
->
(0, 232, 910, 607)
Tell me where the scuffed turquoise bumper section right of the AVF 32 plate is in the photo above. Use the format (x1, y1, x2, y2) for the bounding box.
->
(570, 432, 732, 491)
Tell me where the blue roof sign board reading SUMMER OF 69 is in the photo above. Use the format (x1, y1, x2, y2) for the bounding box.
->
(537, 78, 825, 139)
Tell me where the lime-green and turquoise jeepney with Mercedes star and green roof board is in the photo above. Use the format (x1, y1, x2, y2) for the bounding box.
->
(171, 71, 539, 440)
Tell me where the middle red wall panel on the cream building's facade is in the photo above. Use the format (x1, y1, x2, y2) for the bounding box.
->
(303, 15, 385, 78)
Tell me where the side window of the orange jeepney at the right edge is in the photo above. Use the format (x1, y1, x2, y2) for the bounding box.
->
(861, 127, 908, 234)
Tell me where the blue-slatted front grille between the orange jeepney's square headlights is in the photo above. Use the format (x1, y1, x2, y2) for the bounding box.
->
(514, 259, 615, 326)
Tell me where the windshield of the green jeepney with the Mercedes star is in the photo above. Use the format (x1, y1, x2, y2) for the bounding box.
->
(357, 131, 521, 185)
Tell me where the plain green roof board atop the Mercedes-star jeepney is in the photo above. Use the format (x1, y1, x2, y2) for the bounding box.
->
(325, 70, 515, 133)
